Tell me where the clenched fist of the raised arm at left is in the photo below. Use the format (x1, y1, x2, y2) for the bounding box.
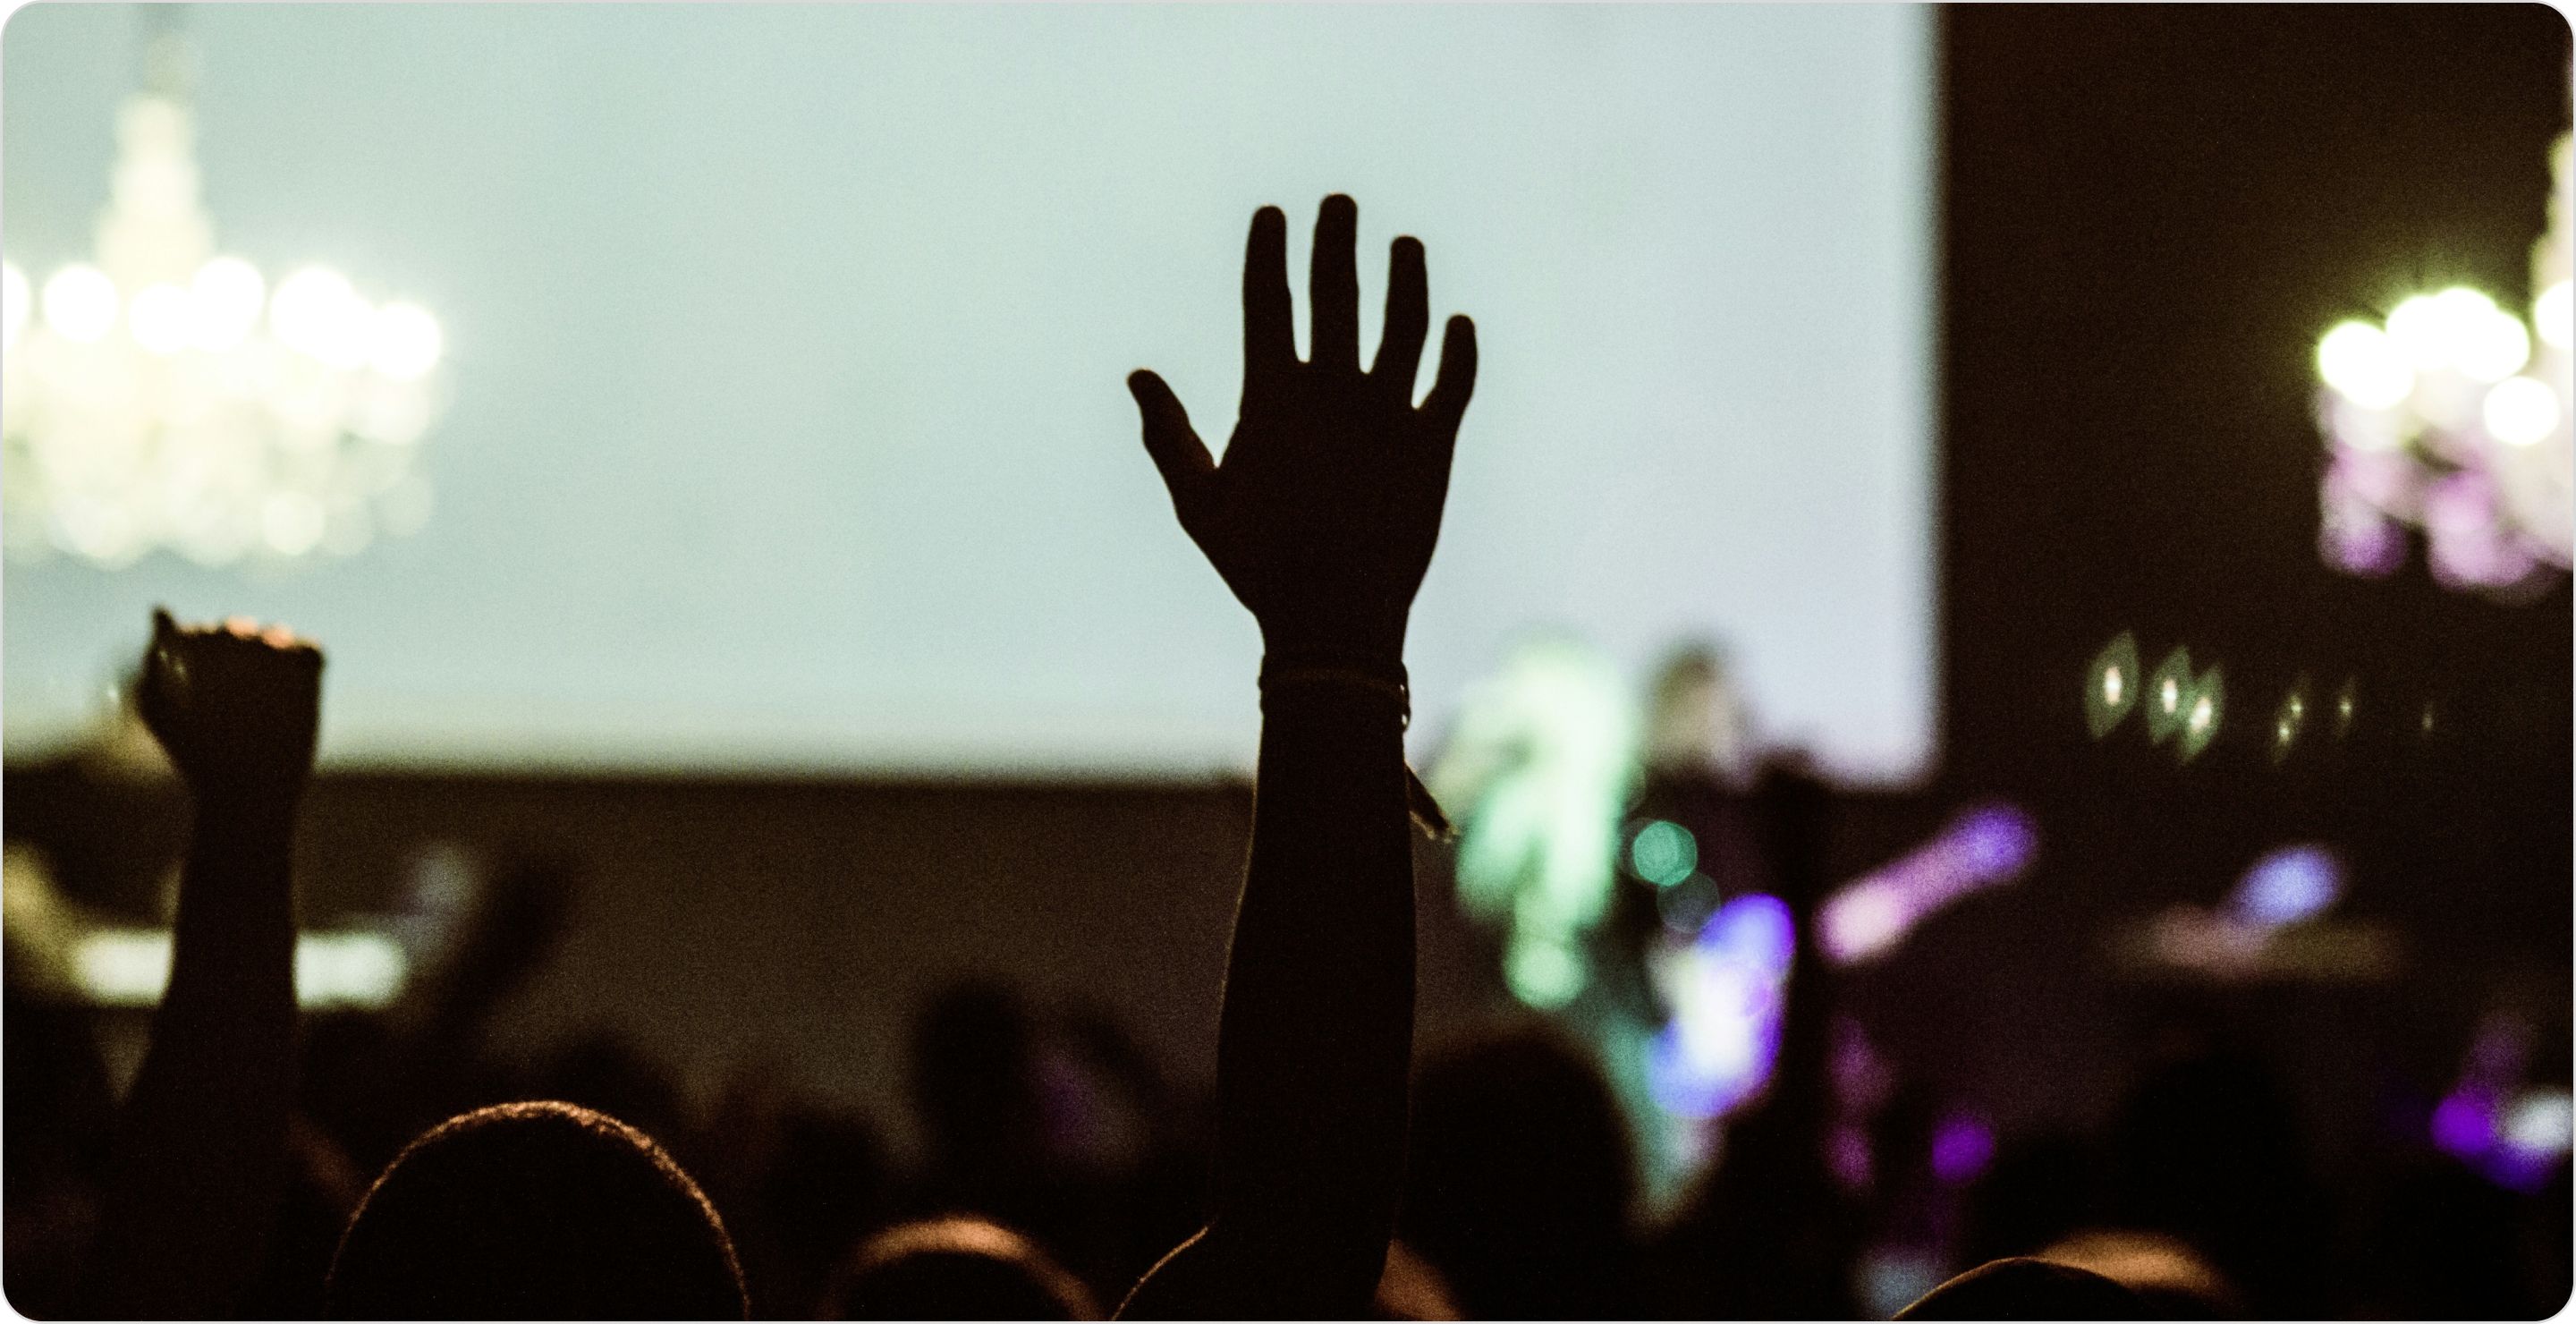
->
(137, 610, 322, 803)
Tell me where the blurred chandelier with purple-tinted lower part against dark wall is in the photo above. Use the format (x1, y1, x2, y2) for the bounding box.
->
(2316, 137, 2576, 600)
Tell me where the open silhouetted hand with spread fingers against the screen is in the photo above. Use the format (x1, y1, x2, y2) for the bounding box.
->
(1128, 193, 1476, 665)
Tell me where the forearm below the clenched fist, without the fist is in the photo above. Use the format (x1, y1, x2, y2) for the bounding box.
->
(88, 799, 296, 1319)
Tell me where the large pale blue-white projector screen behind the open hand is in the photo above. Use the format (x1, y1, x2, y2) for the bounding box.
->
(0, 5, 1935, 780)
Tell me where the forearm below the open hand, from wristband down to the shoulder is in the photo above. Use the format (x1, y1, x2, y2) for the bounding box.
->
(1121, 685, 1414, 1319)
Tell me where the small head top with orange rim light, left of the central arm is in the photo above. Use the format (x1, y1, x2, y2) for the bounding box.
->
(825, 1218, 1100, 1319)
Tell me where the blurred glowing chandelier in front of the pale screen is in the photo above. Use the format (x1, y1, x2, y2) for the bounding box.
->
(0, 15, 443, 569)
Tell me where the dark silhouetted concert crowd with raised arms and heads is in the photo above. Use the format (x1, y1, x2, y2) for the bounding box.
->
(5, 196, 2571, 1319)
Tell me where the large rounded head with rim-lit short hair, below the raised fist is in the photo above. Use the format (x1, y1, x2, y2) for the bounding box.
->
(325, 1102, 747, 1319)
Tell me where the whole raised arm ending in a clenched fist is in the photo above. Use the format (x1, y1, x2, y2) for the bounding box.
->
(85, 613, 322, 1319)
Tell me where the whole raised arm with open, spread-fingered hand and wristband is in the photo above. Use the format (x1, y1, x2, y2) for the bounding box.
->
(1121, 196, 1476, 1319)
